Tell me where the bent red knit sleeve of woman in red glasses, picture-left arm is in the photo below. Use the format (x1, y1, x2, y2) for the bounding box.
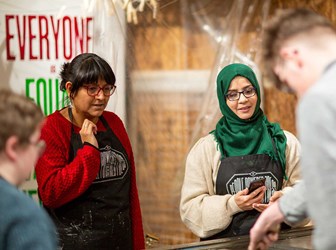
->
(35, 114, 100, 208)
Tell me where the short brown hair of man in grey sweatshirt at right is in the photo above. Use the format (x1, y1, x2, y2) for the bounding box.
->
(262, 8, 336, 87)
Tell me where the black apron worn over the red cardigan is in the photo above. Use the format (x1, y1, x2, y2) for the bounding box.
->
(47, 108, 132, 250)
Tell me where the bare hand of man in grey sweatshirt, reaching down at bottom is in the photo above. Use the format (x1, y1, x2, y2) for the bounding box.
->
(248, 201, 284, 250)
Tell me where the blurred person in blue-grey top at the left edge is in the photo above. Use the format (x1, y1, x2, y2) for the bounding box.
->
(0, 89, 57, 250)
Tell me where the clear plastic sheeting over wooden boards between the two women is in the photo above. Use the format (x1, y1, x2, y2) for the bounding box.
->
(127, 0, 270, 245)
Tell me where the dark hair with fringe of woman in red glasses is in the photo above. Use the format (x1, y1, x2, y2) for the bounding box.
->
(60, 53, 116, 97)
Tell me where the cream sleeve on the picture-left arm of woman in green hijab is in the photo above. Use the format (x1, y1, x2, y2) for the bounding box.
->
(180, 135, 242, 238)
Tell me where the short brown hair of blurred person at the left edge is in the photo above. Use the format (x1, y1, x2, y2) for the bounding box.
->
(0, 89, 44, 151)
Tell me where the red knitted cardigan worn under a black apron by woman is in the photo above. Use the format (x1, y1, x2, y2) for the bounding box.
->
(35, 111, 145, 249)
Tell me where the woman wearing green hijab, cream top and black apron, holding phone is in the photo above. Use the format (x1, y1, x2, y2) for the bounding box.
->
(180, 63, 300, 239)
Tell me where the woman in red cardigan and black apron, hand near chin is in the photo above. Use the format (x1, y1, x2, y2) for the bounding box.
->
(36, 53, 144, 250)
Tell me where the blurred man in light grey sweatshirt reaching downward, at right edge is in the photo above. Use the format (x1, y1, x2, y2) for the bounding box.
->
(249, 9, 336, 250)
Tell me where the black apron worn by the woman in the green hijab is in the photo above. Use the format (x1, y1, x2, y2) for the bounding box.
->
(201, 154, 283, 240)
